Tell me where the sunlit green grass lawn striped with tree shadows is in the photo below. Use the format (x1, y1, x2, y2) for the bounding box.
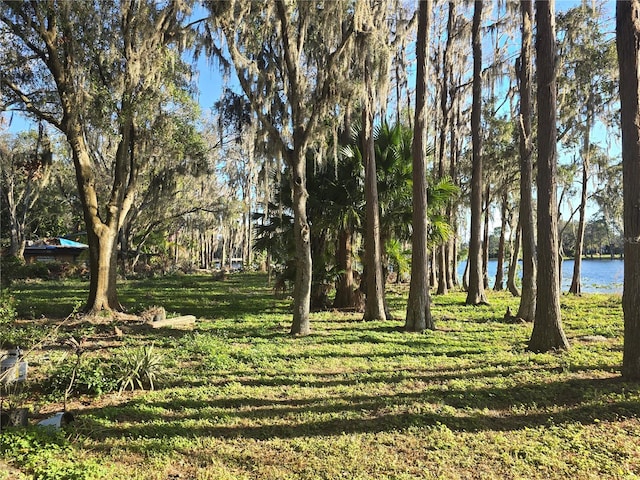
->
(0, 273, 640, 480)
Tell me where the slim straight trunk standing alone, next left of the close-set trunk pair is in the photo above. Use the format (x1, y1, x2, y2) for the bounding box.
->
(466, 1, 487, 305)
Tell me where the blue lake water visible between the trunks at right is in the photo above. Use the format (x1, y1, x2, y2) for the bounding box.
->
(458, 258, 624, 294)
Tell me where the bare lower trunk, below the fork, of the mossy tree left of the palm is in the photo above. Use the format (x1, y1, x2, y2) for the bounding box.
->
(289, 150, 312, 335)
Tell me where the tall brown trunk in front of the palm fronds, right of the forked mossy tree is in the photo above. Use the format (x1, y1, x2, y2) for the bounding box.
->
(362, 63, 386, 320)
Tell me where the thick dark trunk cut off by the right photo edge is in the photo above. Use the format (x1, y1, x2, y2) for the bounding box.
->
(616, 0, 640, 380)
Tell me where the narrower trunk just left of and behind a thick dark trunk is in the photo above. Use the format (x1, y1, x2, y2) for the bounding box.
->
(516, 0, 537, 322)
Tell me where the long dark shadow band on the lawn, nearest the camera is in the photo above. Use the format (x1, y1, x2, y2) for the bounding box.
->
(76, 379, 640, 446)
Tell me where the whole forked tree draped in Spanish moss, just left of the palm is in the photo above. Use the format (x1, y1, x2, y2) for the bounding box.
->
(207, 0, 359, 335)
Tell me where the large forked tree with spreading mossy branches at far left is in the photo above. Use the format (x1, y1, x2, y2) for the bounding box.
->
(0, 0, 194, 312)
